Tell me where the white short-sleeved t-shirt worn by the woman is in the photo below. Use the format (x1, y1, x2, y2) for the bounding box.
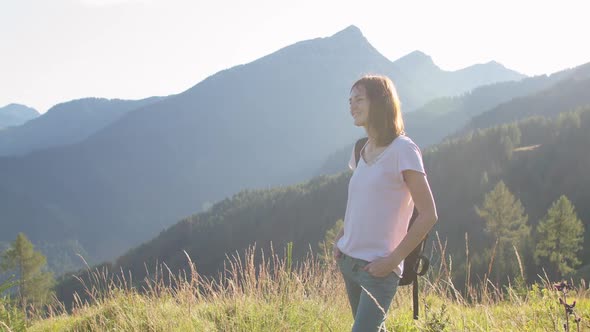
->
(337, 135, 426, 276)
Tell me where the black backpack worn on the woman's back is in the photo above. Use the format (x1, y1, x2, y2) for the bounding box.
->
(354, 137, 430, 319)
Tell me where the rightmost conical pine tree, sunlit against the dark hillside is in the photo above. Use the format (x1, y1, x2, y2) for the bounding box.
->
(535, 195, 584, 278)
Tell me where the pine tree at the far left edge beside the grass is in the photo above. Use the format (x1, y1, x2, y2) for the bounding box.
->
(0, 233, 54, 309)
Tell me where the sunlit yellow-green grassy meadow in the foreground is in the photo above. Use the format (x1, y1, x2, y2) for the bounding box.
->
(15, 250, 590, 332)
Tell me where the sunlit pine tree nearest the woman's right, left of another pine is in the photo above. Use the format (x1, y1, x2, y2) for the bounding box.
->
(476, 181, 531, 283)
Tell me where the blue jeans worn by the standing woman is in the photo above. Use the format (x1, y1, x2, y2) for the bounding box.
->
(337, 254, 399, 332)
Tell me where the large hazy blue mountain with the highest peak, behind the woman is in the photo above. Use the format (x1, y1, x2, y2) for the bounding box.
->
(0, 27, 528, 260)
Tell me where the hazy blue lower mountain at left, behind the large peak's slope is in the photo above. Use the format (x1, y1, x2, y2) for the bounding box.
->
(0, 97, 162, 156)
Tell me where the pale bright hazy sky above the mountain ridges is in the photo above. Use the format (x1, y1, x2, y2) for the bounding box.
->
(0, 0, 590, 113)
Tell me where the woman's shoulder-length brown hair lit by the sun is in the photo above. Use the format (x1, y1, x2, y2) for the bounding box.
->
(350, 75, 405, 146)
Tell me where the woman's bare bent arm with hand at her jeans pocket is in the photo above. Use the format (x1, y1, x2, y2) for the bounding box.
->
(365, 170, 438, 277)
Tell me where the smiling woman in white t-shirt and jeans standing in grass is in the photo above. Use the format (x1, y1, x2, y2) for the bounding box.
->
(334, 76, 437, 332)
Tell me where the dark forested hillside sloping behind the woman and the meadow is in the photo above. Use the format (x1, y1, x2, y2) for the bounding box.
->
(59, 108, 590, 306)
